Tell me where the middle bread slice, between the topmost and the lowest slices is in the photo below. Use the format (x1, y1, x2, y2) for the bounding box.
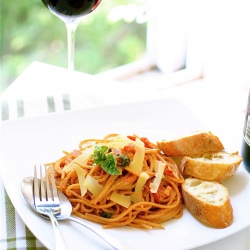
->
(180, 152, 242, 181)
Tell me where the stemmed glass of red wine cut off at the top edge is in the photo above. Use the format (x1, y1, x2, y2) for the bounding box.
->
(42, 0, 102, 71)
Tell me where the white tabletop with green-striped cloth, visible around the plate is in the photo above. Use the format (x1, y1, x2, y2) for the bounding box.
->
(0, 62, 250, 250)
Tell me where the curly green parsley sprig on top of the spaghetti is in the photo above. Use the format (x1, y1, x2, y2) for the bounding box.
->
(93, 145, 120, 175)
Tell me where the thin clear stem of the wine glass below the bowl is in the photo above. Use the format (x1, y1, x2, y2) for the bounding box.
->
(66, 22, 78, 71)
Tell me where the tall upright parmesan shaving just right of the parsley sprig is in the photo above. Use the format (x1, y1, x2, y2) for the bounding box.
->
(129, 138, 145, 175)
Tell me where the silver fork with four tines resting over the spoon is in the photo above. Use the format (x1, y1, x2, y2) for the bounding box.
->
(33, 165, 66, 250)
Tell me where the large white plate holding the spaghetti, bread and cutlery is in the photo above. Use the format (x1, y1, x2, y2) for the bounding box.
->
(0, 99, 250, 250)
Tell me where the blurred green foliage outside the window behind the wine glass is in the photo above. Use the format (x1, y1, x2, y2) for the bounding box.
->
(0, 0, 147, 92)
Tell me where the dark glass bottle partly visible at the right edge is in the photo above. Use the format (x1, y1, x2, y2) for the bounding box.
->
(242, 91, 250, 172)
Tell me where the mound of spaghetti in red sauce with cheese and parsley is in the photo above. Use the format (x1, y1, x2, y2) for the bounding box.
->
(48, 134, 183, 229)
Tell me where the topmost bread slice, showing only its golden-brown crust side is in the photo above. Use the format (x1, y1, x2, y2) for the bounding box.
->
(157, 132, 224, 157)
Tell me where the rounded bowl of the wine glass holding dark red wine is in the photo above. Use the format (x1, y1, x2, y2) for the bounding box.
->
(42, 0, 101, 21)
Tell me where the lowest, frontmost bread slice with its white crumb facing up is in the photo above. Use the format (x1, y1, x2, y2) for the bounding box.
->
(182, 178, 233, 228)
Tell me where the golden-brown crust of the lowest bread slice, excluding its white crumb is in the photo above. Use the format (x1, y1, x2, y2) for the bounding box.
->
(182, 178, 233, 228)
